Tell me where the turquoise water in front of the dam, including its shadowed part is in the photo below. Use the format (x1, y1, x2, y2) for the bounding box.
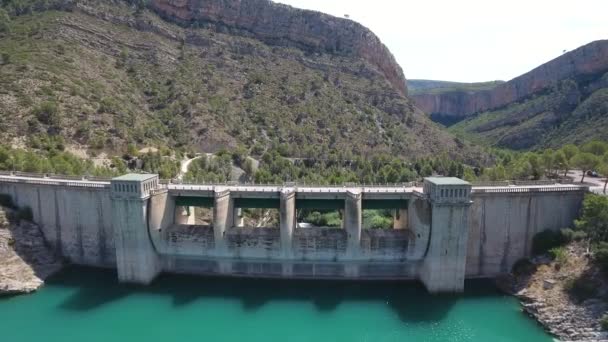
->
(0, 268, 552, 342)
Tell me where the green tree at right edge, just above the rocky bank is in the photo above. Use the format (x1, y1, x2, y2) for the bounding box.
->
(574, 194, 608, 242)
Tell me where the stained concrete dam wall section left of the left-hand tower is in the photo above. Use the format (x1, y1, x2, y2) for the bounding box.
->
(0, 174, 116, 267)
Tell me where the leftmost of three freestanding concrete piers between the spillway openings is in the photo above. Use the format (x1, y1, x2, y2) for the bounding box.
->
(213, 188, 234, 256)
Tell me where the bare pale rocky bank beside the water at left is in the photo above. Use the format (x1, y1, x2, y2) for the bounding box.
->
(0, 207, 63, 296)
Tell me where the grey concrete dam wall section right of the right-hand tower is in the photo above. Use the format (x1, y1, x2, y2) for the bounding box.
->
(466, 187, 585, 277)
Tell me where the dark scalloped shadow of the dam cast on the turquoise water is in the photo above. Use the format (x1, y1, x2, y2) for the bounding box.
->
(47, 267, 506, 323)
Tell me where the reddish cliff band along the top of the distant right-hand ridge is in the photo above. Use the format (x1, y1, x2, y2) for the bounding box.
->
(412, 40, 608, 118)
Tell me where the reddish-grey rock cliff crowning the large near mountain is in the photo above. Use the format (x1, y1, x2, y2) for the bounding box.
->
(151, 0, 407, 96)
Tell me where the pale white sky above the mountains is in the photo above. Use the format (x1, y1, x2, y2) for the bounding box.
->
(276, 0, 608, 82)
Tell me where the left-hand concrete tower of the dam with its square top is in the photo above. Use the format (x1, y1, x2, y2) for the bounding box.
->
(111, 175, 161, 285)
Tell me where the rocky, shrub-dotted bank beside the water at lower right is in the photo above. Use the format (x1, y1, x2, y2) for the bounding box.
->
(505, 243, 608, 342)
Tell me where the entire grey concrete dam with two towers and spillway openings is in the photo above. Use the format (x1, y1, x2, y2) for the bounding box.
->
(0, 173, 589, 293)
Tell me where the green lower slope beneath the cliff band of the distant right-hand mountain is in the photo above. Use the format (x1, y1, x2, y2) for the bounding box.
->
(449, 73, 608, 150)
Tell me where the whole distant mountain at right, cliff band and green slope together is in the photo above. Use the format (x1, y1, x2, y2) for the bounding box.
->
(413, 40, 608, 149)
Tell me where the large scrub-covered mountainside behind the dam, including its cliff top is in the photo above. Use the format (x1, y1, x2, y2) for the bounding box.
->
(0, 0, 484, 158)
